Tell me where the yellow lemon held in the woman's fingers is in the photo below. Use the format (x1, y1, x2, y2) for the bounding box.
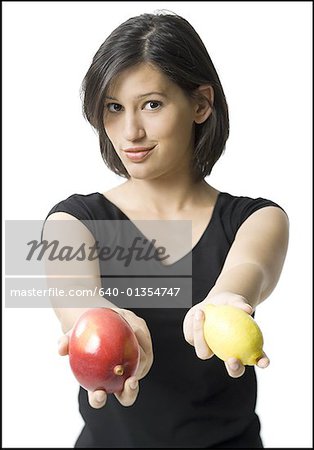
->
(204, 304, 264, 366)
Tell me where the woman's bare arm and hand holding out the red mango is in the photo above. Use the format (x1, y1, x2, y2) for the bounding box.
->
(43, 212, 153, 408)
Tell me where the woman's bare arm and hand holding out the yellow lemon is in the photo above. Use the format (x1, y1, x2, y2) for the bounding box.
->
(183, 206, 289, 377)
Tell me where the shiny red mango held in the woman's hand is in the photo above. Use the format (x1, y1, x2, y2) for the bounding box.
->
(69, 308, 140, 394)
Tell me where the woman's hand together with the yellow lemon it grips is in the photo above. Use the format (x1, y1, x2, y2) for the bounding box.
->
(183, 293, 269, 378)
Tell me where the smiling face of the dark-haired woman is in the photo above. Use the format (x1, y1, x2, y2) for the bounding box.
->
(104, 63, 196, 179)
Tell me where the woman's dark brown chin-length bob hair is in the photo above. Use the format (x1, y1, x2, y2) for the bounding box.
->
(81, 12, 229, 180)
